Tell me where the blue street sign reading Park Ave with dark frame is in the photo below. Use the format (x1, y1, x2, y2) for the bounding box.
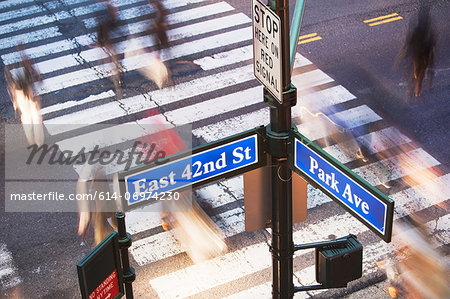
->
(291, 132, 394, 242)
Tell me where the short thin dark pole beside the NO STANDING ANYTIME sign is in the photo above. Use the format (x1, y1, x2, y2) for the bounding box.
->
(116, 211, 136, 299)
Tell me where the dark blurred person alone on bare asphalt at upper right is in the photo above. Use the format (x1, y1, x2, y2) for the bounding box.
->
(399, 6, 436, 97)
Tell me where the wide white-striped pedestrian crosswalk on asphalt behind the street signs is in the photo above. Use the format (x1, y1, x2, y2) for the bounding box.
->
(0, 0, 450, 298)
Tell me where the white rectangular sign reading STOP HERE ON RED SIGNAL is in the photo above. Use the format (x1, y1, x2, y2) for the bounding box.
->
(252, 0, 283, 104)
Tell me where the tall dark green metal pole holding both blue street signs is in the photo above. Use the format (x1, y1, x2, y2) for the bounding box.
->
(264, 0, 297, 299)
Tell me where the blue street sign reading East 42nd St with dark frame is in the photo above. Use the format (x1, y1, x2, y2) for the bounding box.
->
(119, 129, 265, 208)
